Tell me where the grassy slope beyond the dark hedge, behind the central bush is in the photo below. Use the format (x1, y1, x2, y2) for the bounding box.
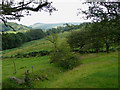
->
(2, 32, 69, 57)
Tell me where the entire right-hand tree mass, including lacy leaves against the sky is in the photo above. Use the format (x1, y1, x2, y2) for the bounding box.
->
(68, 0, 120, 53)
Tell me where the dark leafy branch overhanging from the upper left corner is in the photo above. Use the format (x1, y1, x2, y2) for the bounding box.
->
(0, 0, 56, 31)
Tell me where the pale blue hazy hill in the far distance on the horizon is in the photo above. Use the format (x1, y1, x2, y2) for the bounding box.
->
(30, 22, 81, 30)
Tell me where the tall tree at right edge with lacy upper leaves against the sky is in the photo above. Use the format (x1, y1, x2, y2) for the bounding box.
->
(78, 1, 120, 52)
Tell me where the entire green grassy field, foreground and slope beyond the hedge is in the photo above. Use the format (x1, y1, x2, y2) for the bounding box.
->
(2, 32, 118, 88)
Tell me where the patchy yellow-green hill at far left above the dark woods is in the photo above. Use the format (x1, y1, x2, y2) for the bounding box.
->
(0, 22, 32, 32)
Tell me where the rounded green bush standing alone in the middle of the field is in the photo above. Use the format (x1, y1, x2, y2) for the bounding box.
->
(50, 41, 79, 69)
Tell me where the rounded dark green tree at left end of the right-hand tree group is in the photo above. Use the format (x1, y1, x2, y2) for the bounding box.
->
(67, 24, 92, 52)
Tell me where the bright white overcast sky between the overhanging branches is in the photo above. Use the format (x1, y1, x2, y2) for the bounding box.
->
(9, 0, 89, 26)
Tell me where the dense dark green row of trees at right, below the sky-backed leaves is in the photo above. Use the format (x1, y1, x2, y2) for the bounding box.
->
(67, 20, 120, 53)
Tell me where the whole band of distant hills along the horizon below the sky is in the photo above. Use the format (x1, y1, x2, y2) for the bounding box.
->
(0, 22, 81, 33)
